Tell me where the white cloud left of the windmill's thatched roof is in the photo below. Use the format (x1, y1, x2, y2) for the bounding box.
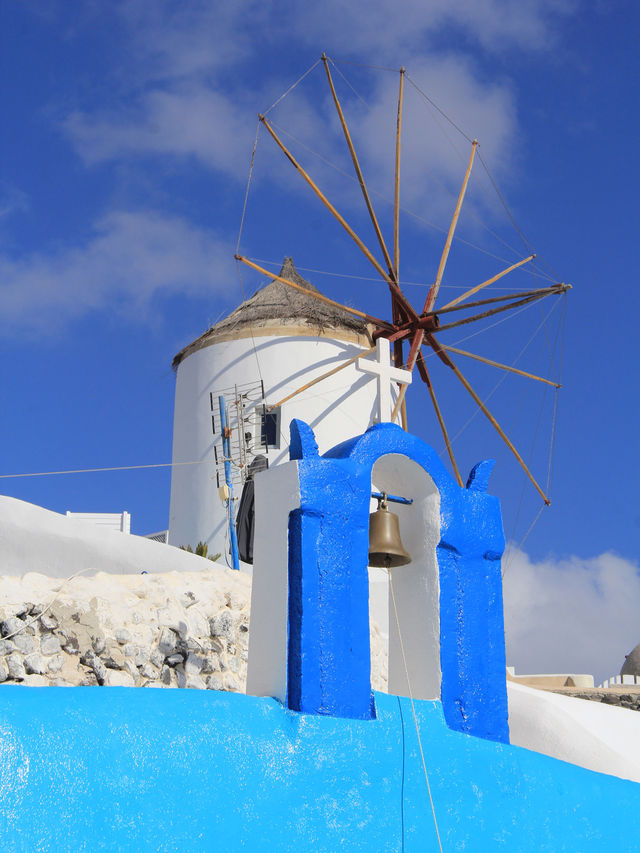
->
(0, 211, 233, 335)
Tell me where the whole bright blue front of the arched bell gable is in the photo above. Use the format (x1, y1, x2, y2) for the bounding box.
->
(287, 420, 509, 742)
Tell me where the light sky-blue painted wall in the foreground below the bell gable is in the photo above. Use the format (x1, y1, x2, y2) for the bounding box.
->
(0, 687, 640, 853)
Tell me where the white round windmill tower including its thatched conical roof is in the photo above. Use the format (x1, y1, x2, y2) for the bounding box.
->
(168, 258, 404, 559)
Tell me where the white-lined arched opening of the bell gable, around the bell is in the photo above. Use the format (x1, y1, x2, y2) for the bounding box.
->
(369, 453, 442, 699)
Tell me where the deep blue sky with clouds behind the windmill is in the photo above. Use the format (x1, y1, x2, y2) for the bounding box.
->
(0, 0, 640, 680)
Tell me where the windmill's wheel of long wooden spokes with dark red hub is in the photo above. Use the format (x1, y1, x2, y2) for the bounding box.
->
(235, 54, 571, 505)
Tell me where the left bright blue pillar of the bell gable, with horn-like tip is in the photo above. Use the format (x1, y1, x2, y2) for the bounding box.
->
(287, 421, 375, 720)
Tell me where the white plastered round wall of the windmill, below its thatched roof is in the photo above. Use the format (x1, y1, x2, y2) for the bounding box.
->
(169, 335, 377, 561)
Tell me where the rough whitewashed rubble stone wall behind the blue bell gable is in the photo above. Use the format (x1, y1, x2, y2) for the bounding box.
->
(0, 565, 386, 692)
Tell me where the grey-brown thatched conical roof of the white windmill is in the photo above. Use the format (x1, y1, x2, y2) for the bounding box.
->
(173, 258, 368, 367)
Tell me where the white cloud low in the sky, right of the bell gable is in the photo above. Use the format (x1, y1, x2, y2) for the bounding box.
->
(504, 551, 640, 683)
